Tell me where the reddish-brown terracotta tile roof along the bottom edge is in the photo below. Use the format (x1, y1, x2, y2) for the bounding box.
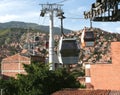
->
(52, 89, 120, 95)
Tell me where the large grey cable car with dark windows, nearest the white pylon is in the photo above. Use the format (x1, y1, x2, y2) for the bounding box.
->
(58, 37, 80, 64)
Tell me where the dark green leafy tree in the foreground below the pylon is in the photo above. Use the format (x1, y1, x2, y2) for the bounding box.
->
(0, 63, 80, 95)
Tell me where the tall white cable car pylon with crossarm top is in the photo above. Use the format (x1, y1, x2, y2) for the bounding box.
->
(40, 4, 62, 70)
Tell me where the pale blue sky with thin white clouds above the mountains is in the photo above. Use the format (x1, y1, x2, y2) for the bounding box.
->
(0, 0, 120, 33)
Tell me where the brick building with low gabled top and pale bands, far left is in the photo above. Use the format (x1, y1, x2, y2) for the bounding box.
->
(1, 54, 31, 77)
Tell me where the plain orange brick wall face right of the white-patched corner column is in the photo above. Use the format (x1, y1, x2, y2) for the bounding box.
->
(90, 42, 120, 90)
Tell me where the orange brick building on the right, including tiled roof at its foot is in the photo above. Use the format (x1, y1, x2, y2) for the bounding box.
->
(52, 42, 120, 95)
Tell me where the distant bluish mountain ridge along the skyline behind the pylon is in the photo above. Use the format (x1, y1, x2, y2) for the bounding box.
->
(0, 21, 71, 34)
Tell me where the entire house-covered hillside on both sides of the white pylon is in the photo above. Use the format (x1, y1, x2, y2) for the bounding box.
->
(0, 22, 120, 63)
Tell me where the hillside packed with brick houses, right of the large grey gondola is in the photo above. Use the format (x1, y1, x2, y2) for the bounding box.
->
(71, 28, 120, 63)
